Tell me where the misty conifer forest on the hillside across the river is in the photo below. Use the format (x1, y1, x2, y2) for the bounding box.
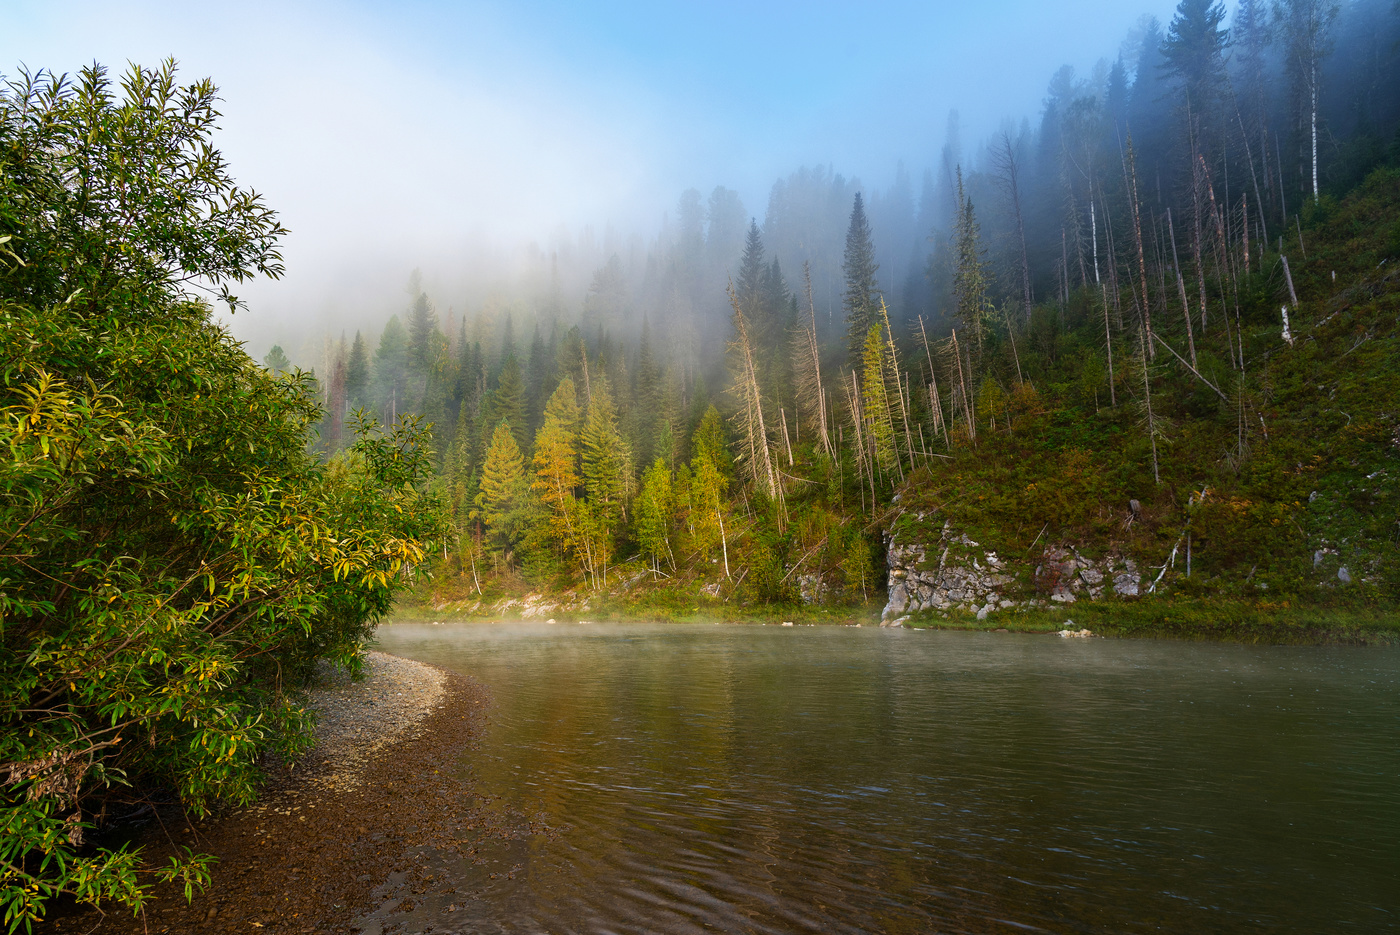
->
(275, 0, 1400, 621)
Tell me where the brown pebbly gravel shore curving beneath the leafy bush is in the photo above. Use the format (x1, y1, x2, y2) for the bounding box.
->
(56, 652, 500, 935)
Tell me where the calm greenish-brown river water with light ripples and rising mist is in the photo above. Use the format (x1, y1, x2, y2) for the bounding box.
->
(365, 624, 1400, 934)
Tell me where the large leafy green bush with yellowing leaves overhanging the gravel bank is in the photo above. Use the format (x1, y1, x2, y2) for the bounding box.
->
(0, 64, 440, 931)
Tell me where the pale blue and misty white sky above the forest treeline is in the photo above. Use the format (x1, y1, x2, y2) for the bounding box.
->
(0, 0, 1175, 342)
